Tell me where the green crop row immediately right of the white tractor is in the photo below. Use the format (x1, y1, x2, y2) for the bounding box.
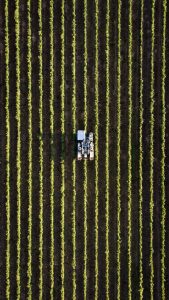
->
(95, 0, 99, 300)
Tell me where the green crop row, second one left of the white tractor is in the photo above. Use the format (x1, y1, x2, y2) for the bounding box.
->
(60, 0, 65, 300)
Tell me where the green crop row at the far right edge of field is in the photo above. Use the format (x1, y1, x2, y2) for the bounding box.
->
(161, 0, 167, 300)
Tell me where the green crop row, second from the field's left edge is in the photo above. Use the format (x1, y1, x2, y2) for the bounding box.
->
(15, 0, 21, 299)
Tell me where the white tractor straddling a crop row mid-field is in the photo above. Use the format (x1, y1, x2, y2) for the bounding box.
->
(77, 130, 94, 160)
